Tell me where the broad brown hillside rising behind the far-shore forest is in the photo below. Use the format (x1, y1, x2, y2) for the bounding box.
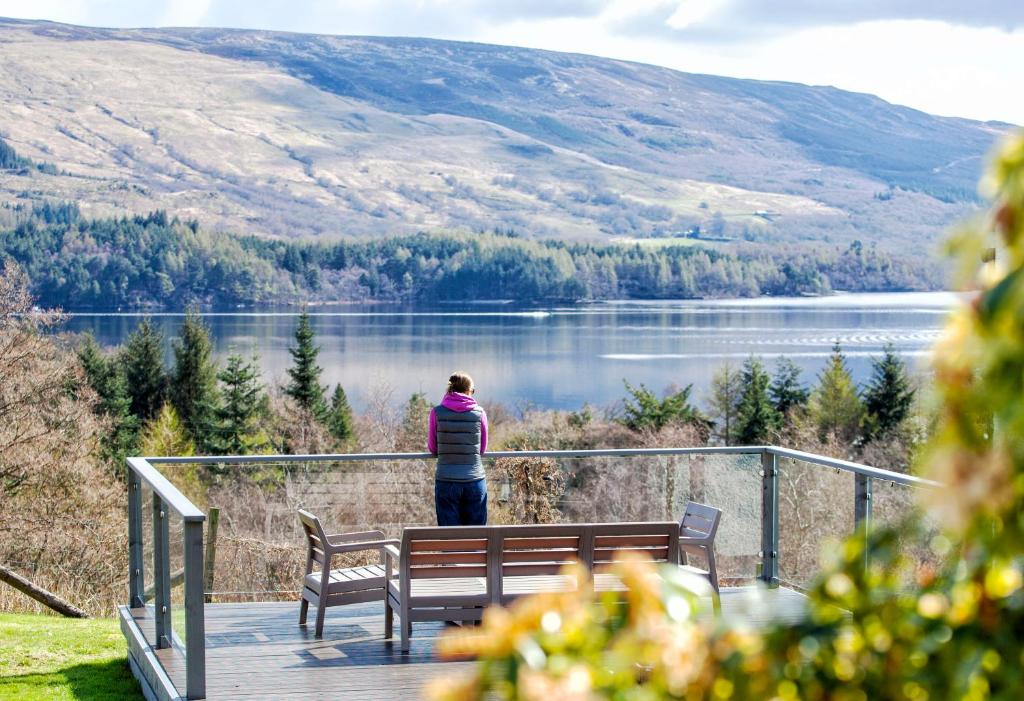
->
(0, 19, 1010, 250)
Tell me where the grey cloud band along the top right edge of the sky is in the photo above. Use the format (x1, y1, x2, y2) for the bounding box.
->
(613, 0, 1024, 41)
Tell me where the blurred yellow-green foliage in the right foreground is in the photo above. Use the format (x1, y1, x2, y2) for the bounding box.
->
(431, 135, 1024, 701)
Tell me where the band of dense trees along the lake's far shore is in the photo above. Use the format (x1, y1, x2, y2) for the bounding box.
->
(0, 203, 943, 310)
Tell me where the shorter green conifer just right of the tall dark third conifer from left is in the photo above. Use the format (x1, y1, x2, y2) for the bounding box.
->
(216, 353, 266, 455)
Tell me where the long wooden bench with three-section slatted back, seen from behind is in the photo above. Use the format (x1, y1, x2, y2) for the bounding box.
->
(384, 521, 679, 652)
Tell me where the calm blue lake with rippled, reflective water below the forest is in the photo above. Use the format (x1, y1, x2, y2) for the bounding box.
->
(66, 293, 957, 410)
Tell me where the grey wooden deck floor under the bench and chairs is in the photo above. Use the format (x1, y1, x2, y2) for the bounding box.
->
(122, 588, 806, 701)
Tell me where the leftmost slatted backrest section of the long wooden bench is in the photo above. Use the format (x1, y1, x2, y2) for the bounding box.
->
(401, 526, 490, 579)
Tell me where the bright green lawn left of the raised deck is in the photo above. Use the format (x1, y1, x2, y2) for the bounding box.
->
(0, 613, 142, 701)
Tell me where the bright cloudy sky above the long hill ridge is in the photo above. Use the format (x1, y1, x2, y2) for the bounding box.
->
(0, 0, 1024, 125)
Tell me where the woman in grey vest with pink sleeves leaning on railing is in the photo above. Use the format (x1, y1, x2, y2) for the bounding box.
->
(427, 373, 487, 526)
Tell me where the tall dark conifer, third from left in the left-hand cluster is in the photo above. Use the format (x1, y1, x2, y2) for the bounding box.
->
(169, 311, 218, 450)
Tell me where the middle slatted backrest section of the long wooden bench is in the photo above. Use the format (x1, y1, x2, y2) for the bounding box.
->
(498, 524, 589, 577)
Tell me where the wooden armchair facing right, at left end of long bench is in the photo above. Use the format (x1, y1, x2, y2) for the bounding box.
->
(299, 509, 398, 638)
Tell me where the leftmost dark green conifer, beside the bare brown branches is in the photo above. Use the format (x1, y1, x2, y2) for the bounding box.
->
(78, 334, 139, 464)
